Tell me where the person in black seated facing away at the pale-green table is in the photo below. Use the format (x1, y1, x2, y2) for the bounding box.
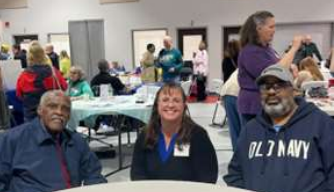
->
(90, 59, 126, 96)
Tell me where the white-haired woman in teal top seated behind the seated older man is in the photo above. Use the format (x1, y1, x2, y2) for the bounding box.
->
(66, 66, 93, 100)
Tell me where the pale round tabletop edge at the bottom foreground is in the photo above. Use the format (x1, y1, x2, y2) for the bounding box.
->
(56, 181, 249, 192)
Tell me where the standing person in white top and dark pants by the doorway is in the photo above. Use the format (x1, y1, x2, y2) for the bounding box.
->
(193, 41, 209, 101)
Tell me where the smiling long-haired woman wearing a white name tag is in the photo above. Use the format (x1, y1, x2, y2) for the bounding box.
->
(131, 82, 218, 183)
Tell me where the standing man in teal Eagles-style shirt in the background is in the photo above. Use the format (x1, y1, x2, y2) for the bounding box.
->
(157, 36, 183, 82)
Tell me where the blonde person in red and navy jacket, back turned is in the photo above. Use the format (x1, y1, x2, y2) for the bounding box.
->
(16, 41, 67, 121)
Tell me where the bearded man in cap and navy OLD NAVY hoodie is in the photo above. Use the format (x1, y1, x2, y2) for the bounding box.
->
(224, 65, 334, 192)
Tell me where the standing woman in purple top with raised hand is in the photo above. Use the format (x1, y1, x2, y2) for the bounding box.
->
(238, 11, 303, 125)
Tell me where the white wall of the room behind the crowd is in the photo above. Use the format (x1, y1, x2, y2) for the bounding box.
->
(0, 0, 334, 78)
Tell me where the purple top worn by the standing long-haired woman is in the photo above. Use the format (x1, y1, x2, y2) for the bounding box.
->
(238, 45, 279, 115)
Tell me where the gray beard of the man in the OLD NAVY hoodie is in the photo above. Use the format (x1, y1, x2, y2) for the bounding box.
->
(262, 98, 292, 118)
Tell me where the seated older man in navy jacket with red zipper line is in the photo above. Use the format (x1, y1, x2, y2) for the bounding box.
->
(0, 90, 106, 192)
